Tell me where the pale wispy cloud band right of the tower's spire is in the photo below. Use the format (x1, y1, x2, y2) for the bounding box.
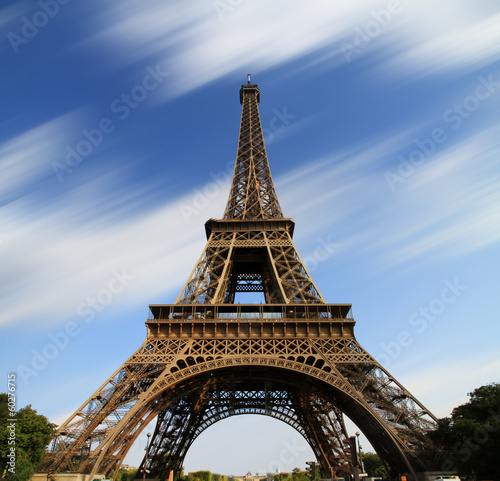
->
(277, 120, 500, 265)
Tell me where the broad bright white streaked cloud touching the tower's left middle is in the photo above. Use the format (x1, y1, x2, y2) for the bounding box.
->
(0, 174, 207, 327)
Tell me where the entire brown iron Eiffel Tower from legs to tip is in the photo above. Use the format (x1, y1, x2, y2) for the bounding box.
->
(41, 76, 438, 480)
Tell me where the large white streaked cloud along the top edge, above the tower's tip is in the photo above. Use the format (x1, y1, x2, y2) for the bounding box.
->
(70, 0, 500, 97)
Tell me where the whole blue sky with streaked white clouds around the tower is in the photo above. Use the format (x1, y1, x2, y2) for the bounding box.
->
(0, 0, 500, 474)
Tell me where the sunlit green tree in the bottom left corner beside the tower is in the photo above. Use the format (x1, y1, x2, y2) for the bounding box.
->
(0, 393, 56, 481)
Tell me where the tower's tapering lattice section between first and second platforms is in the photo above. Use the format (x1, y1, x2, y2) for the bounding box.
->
(176, 230, 325, 304)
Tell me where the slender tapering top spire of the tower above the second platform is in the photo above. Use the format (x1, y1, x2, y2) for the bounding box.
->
(224, 78, 283, 220)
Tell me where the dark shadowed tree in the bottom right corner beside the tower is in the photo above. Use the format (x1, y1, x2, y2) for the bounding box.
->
(430, 383, 500, 481)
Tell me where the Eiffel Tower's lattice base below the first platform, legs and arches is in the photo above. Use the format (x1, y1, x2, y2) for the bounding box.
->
(42, 337, 442, 476)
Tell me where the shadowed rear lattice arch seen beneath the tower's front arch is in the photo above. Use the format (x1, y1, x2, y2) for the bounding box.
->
(139, 377, 347, 478)
